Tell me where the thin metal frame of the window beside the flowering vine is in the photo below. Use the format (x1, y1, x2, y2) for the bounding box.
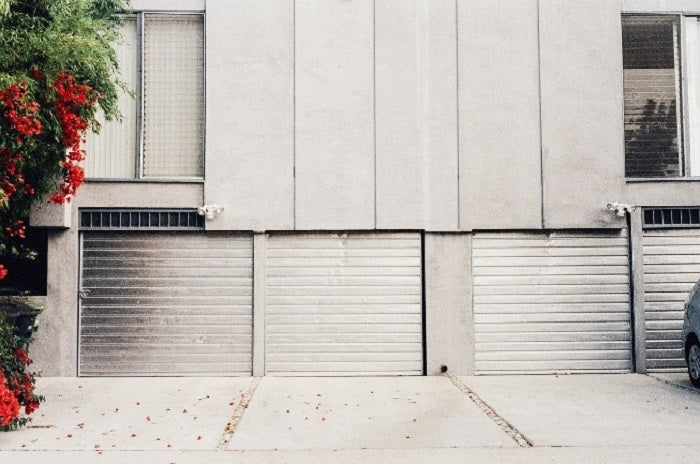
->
(85, 10, 207, 183)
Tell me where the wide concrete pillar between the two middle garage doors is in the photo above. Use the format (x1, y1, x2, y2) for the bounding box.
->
(424, 233, 474, 375)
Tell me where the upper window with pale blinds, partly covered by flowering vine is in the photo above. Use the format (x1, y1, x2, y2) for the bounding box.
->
(85, 13, 204, 179)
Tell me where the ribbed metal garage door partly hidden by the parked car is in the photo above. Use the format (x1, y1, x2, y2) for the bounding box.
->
(643, 229, 700, 372)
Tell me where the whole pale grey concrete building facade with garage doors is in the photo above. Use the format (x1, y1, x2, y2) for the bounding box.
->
(27, 0, 700, 376)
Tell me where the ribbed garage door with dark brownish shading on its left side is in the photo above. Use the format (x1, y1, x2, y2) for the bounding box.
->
(79, 232, 253, 376)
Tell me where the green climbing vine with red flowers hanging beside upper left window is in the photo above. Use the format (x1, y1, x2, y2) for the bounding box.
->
(0, 0, 128, 279)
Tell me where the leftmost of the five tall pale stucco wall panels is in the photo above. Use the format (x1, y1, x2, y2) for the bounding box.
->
(205, 0, 294, 230)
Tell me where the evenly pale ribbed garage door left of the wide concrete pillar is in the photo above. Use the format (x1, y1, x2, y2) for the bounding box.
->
(265, 233, 423, 375)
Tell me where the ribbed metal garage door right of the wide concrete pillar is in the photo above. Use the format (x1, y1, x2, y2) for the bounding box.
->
(472, 232, 632, 374)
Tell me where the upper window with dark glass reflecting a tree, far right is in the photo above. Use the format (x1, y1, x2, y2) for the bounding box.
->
(622, 15, 700, 178)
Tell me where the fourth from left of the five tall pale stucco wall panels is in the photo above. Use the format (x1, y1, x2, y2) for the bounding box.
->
(458, 0, 542, 229)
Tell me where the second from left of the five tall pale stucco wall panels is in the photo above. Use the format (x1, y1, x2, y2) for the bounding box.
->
(295, 0, 376, 229)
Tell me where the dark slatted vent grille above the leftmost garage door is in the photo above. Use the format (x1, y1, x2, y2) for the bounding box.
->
(80, 209, 204, 230)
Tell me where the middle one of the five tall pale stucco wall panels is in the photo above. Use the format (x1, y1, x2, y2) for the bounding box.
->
(375, 0, 458, 230)
